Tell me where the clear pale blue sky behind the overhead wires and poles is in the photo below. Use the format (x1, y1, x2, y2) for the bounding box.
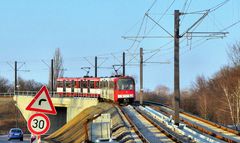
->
(0, 0, 240, 89)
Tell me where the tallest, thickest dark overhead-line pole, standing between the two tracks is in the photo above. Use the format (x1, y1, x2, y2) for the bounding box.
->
(174, 10, 180, 125)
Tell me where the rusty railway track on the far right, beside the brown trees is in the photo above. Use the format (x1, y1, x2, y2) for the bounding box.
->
(144, 102, 240, 143)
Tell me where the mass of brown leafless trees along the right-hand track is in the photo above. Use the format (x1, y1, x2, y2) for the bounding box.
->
(188, 42, 240, 125)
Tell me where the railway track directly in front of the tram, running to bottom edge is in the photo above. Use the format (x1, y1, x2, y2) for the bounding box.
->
(121, 106, 188, 143)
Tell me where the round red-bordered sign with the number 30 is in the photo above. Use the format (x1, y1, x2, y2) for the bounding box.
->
(27, 113, 50, 135)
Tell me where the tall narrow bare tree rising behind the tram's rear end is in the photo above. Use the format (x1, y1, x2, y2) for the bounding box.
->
(49, 48, 64, 89)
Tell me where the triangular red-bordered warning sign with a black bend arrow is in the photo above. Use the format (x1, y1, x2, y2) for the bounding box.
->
(26, 86, 57, 115)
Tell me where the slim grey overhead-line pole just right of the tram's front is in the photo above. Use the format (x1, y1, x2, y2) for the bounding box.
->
(139, 48, 143, 105)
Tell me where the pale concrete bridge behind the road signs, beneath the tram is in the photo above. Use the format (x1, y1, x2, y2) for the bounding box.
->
(13, 94, 98, 134)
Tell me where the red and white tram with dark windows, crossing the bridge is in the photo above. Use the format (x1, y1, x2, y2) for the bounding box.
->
(57, 76, 135, 103)
